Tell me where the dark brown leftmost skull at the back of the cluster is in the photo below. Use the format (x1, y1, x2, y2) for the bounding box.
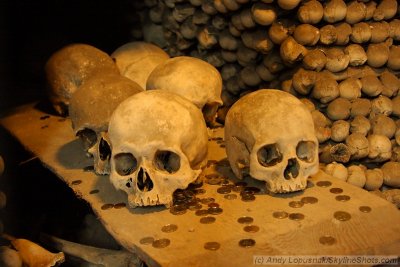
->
(45, 44, 119, 116)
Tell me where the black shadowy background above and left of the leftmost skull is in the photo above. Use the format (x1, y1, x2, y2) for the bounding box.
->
(0, 0, 142, 111)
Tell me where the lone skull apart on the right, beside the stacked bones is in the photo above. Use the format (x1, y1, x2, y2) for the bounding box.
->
(225, 89, 318, 193)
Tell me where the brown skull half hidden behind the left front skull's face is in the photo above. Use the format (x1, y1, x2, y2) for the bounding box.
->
(69, 73, 143, 174)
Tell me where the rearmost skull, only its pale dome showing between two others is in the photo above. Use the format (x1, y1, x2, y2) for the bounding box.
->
(111, 42, 169, 88)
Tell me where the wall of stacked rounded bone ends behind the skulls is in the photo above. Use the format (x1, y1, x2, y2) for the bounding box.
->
(136, 0, 400, 195)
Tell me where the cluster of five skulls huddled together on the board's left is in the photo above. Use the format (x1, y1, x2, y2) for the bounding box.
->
(46, 42, 222, 206)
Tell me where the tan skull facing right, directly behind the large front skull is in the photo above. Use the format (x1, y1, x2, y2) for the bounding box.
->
(146, 56, 222, 126)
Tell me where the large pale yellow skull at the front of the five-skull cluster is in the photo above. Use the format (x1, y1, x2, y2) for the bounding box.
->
(109, 90, 208, 206)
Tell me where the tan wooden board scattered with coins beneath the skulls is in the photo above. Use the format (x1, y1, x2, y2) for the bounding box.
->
(0, 105, 400, 266)
